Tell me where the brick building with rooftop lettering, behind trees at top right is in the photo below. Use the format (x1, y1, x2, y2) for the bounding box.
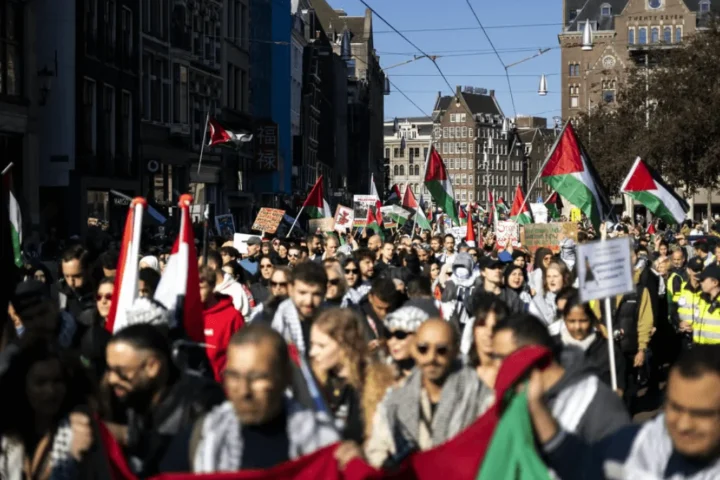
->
(558, 0, 720, 218)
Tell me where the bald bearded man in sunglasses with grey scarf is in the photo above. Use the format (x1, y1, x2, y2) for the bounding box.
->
(365, 318, 493, 467)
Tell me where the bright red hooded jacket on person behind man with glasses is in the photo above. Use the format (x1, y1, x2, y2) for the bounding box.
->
(203, 295, 245, 382)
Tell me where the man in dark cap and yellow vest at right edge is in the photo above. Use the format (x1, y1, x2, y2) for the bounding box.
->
(680, 264, 720, 345)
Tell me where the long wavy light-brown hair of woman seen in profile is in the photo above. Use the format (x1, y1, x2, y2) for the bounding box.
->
(313, 308, 368, 391)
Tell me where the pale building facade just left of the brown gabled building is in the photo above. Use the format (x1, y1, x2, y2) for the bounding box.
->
(384, 117, 433, 196)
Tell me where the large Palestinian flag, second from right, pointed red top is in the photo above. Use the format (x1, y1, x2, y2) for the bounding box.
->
(540, 122, 613, 230)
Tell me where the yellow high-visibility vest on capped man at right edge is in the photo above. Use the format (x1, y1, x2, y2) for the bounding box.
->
(678, 284, 720, 345)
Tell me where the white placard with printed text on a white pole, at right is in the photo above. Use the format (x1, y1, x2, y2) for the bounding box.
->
(575, 238, 635, 302)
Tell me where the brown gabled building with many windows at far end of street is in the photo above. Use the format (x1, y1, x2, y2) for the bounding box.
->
(433, 86, 537, 210)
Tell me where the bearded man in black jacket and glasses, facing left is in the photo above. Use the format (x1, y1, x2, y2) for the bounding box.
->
(106, 324, 225, 478)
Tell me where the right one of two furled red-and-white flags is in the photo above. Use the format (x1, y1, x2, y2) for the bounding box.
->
(155, 194, 205, 343)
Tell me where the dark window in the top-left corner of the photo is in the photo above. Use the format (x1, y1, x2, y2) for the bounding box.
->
(0, 0, 24, 96)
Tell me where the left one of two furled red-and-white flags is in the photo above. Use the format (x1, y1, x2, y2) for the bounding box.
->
(105, 197, 147, 333)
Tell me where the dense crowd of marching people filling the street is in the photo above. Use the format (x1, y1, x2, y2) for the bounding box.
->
(0, 215, 720, 480)
